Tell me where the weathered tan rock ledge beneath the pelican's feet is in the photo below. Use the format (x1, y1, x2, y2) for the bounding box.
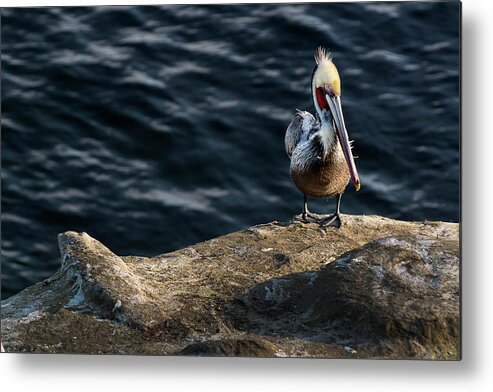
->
(2, 216, 460, 359)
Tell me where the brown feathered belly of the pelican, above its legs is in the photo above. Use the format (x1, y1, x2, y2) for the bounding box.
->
(291, 139, 349, 197)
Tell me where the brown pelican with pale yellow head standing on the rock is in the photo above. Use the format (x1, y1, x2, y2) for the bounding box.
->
(284, 48, 360, 226)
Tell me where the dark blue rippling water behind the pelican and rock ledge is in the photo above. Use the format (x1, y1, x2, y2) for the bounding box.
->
(1, 2, 460, 298)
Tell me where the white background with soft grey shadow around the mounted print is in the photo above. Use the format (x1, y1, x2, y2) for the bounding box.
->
(0, 0, 493, 392)
